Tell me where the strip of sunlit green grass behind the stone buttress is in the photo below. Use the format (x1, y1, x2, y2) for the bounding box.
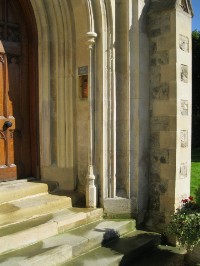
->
(190, 148, 200, 197)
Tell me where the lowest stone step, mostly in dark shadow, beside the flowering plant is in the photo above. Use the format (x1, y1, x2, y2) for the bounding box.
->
(66, 241, 186, 266)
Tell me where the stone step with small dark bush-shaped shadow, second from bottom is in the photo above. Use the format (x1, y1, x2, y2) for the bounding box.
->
(0, 220, 139, 266)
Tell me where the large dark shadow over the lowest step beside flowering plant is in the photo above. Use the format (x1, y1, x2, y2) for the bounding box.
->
(102, 233, 186, 266)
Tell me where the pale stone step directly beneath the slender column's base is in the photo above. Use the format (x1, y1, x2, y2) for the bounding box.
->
(0, 208, 102, 254)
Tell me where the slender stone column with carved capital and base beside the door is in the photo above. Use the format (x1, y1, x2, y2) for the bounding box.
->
(86, 32, 97, 208)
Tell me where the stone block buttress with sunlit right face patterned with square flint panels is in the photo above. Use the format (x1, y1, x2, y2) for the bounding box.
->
(147, 1, 191, 228)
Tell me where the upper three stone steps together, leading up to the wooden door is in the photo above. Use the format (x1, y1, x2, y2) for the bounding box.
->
(0, 181, 103, 255)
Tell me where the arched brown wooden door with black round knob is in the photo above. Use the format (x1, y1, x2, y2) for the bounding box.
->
(0, 0, 37, 180)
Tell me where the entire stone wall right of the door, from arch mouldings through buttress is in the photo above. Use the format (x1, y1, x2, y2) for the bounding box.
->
(28, 0, 191, 226)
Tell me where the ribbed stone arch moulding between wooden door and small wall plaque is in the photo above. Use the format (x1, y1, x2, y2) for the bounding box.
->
(30, 0, 84, 190)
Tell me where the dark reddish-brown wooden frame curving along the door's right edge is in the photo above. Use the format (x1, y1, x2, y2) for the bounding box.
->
(18, 0, 40, 178)
